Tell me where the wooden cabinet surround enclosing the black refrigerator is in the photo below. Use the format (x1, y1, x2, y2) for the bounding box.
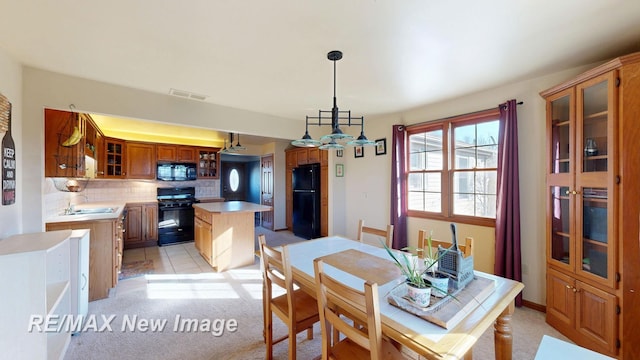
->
(285, 147, 329, 236)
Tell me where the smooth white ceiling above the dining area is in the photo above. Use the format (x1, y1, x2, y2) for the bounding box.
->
(0, 0, 640, 145)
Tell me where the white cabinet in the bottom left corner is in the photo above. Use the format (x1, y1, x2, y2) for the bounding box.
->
(0, 230, 71, 359)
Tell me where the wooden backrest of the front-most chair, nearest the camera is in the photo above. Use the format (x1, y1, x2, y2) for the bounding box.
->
(313, 259, 382, 359)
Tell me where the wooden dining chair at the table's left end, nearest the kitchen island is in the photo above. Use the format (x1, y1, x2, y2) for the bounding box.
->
(258, 235, 320, 360)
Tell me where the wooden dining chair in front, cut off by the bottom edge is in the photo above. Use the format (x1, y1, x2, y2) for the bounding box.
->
(313, 258, 403, 360)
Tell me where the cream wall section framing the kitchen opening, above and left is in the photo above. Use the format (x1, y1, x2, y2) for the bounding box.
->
(20, 67, 300, 231)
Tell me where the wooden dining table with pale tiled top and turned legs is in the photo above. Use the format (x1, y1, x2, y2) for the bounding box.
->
(287, 236, 524, 360)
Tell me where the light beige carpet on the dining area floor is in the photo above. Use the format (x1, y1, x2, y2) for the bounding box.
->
(65, 230, 566, 360)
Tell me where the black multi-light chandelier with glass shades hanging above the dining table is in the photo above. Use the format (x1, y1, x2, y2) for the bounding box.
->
(291, 50, 376, 150)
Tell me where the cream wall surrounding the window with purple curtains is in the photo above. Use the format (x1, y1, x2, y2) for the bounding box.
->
(332, 65, 593, 304)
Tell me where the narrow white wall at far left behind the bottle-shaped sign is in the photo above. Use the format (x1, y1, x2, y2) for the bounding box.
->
(0, 50, 25, 239)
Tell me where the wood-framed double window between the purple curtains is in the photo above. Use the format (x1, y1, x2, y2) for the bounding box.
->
(407, 109, 499, 226)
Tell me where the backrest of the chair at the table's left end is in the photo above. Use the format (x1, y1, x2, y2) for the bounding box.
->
(258, 235, 295, 322)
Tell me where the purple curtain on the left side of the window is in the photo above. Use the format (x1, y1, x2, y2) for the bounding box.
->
(391, 125, 408, 249)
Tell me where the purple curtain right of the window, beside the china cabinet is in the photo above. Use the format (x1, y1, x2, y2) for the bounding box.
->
(495, 100, 522, 306)
